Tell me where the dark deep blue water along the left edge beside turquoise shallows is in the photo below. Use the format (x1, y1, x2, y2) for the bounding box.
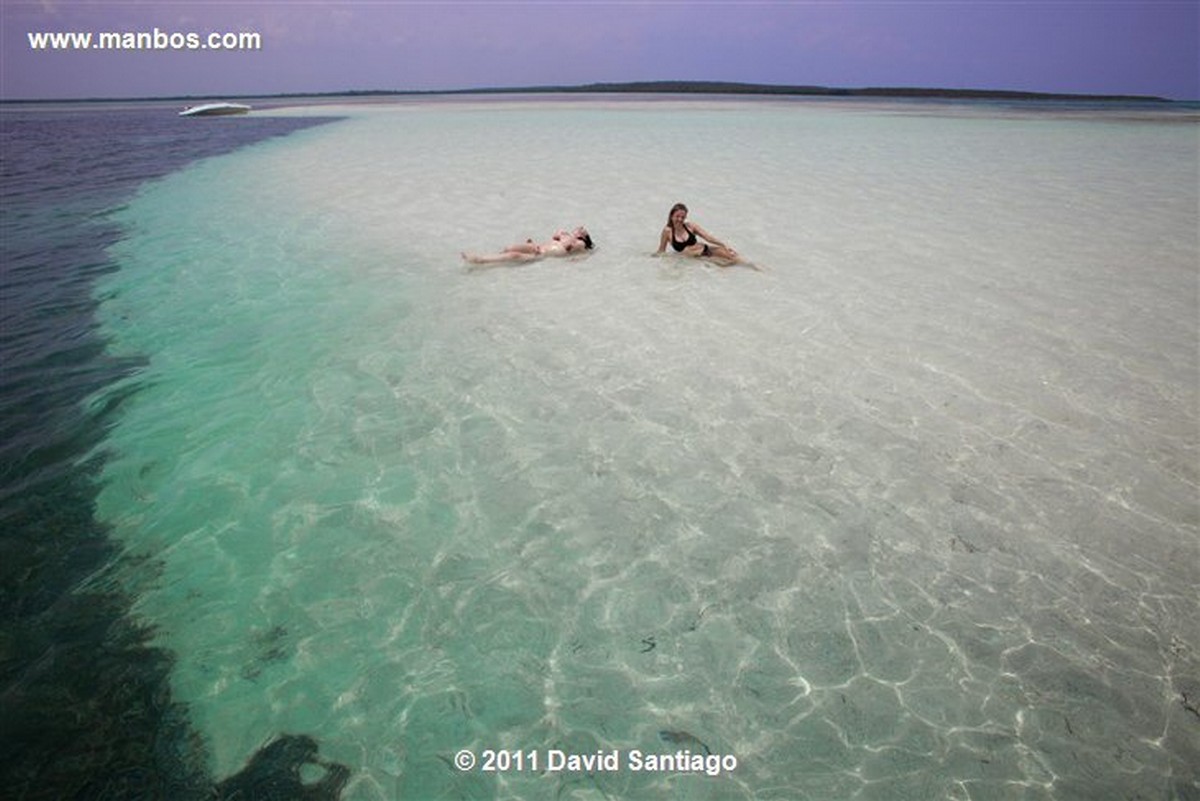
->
(0, 104, 347, 799)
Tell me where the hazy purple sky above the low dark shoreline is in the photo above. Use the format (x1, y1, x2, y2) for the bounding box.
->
(0, 0, 1200, 100)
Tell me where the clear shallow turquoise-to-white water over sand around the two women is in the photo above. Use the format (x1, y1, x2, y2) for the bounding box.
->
(96, 102, 1200, 799)
